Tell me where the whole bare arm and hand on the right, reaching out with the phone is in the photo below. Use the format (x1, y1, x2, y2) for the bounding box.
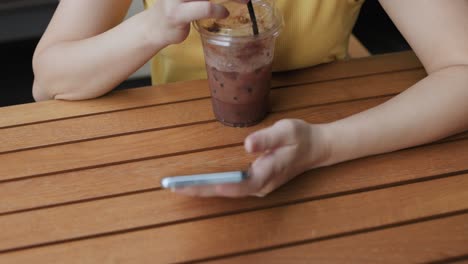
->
(176, 0, 468, 197)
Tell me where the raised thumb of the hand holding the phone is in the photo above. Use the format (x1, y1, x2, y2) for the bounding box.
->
(244, 120, 295, 153)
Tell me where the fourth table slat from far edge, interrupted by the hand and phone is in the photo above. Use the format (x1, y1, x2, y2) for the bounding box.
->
(0, 130, 468, 217)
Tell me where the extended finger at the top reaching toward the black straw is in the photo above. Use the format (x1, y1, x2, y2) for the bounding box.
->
(174, 1, 229, 23)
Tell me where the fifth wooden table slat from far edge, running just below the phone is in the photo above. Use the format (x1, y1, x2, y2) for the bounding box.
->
(0, 141, 468, 250)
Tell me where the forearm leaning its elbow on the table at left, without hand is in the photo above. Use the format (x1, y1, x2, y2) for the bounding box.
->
(33, 11, 168, 100)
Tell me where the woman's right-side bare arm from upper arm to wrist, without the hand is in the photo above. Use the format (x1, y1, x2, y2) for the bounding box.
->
(326, 0, 468, 164)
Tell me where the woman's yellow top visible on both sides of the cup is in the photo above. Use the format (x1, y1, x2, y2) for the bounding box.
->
(144, 0, 364, 84)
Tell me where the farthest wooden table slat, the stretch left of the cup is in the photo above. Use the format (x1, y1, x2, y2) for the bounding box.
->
(0, 80, 209, 128)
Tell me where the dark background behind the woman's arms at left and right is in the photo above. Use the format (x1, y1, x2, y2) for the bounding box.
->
(0, 0, 410, 107)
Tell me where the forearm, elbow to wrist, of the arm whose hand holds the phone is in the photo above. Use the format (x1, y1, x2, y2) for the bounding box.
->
(324, 65, 468, 165)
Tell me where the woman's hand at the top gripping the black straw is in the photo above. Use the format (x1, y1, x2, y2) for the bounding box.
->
(148, 0, 249, 45)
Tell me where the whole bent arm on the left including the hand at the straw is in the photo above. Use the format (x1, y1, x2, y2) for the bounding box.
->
(33, 0, 227, 100)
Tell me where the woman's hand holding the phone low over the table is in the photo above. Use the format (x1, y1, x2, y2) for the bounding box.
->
(175, 119, 330, 197)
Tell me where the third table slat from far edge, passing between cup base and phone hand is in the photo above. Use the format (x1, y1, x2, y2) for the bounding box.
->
(0, 98, 389, 181)
